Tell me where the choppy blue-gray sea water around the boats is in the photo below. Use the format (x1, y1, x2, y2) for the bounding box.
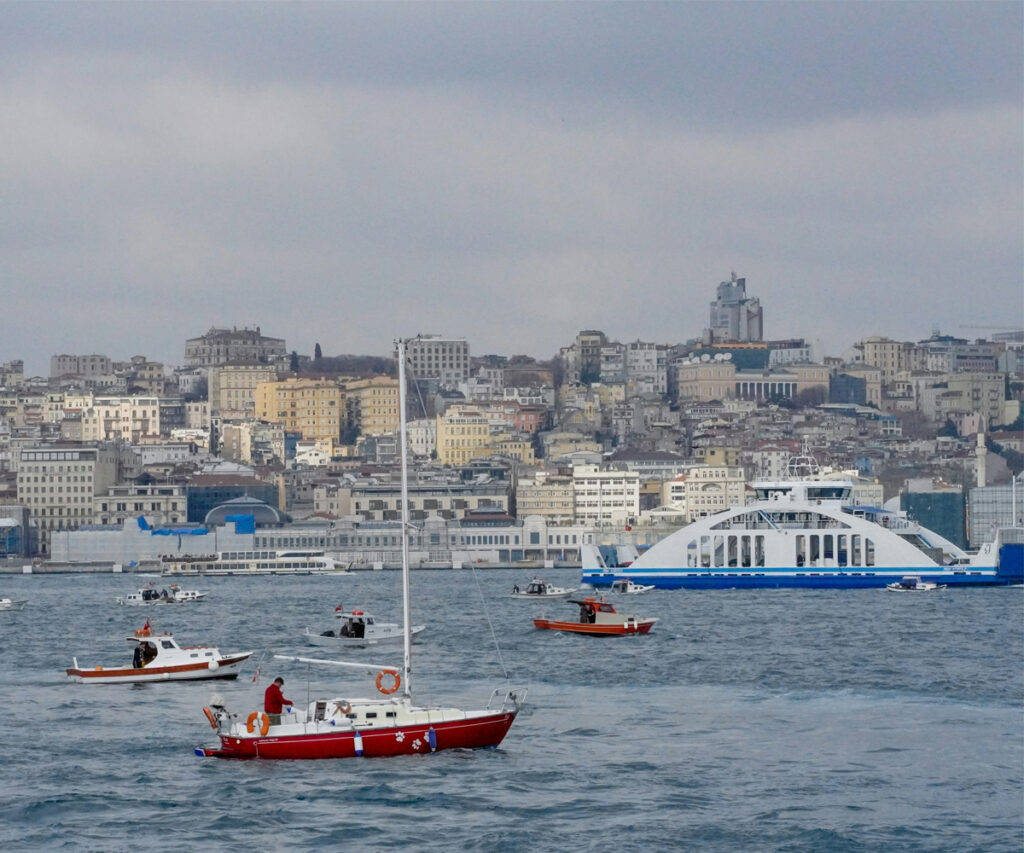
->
(0, 569, 1024, 853)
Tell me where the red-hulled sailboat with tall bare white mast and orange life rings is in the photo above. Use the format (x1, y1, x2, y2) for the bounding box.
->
(196, 341, 526, 759)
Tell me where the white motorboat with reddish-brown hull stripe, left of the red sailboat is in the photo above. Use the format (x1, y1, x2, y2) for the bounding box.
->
(66, 623, 252, 684)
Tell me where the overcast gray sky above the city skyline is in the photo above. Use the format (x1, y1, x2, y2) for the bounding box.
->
(0, 2, 1024, 375)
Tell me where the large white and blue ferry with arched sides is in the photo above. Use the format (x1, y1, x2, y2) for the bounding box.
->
(582, 468, 1024, 590)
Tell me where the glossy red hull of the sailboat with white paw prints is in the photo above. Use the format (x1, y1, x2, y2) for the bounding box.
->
(196, 712, 515, 759)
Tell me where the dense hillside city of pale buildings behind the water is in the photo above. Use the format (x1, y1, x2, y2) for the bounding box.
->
(0, 273, 1024, 567)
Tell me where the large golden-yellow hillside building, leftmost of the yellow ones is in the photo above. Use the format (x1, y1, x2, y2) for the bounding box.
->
(255, 379, 345, 441)
